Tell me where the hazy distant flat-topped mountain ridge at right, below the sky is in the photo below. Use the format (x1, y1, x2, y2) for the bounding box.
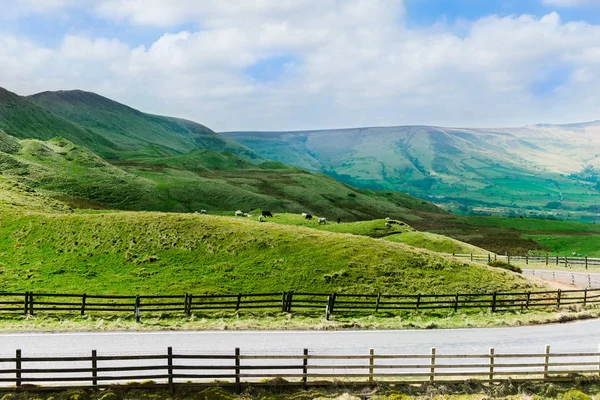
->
(223, 121, 600, 222)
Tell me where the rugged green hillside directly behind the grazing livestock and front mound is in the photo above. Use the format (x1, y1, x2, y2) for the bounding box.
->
(0, 132, 442, 221)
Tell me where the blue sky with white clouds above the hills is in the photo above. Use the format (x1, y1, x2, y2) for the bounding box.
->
(0, 0, 600, 131)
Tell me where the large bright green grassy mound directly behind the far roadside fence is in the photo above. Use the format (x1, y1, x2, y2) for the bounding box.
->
(0, 213, 530, 293)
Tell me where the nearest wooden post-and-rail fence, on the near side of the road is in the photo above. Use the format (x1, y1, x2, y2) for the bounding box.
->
(0, 346, 600, 392)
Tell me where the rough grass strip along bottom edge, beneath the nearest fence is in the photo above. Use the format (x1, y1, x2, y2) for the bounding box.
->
(1, 380, 600, 400)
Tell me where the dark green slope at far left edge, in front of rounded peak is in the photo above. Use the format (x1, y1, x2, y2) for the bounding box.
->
(0, 88, 115, 156)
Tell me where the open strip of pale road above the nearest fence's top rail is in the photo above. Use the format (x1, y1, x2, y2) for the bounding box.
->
(0, 320, 600, 356)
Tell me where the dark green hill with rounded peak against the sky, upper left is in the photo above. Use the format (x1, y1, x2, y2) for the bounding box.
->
(27, 90, 261, 161)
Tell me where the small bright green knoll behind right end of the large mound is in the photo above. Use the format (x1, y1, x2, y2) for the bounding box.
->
(384, 232, 489, 254)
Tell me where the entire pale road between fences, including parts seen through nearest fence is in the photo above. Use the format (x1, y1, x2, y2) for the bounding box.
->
(0, 320, 600, 386)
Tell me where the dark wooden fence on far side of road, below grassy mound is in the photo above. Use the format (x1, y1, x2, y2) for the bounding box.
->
(0, 289, 600, 321)
